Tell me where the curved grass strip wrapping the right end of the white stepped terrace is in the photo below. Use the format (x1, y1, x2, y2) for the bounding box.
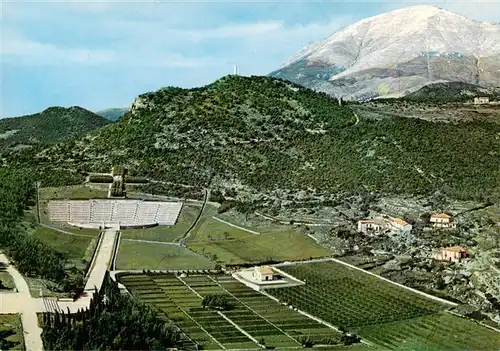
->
(122, 205, 201, 242)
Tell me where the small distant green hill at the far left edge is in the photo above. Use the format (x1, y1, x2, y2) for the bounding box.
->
(0, 106, 109, 152)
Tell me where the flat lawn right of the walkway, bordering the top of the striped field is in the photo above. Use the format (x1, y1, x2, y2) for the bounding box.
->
(116, 240, 214, 270)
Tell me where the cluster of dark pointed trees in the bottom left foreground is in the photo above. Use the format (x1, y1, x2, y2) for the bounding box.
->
(42, 277, 180, 350)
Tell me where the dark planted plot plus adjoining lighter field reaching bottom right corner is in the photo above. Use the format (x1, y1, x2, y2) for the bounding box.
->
(268, 261, 500, 351)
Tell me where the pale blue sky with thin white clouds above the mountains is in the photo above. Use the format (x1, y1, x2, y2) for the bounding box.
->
(0, 0, 500, 117)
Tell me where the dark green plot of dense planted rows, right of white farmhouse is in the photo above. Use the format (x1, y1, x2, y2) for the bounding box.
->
(268, 261, 447, 328)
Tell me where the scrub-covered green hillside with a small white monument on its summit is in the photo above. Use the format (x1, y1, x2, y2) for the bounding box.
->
(26, 76, 500, 204)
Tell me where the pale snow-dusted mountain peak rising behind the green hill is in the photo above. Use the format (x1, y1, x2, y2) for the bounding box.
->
(270, 5, 500, 100)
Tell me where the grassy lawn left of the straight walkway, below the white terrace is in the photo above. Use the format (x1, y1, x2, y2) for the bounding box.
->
(32, 227, 97, 262)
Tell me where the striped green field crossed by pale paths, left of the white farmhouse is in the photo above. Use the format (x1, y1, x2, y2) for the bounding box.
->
(120, 275, 348, 349)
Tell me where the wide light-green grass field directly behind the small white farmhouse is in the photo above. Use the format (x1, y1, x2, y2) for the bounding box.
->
(188, 230, 330, 264)
